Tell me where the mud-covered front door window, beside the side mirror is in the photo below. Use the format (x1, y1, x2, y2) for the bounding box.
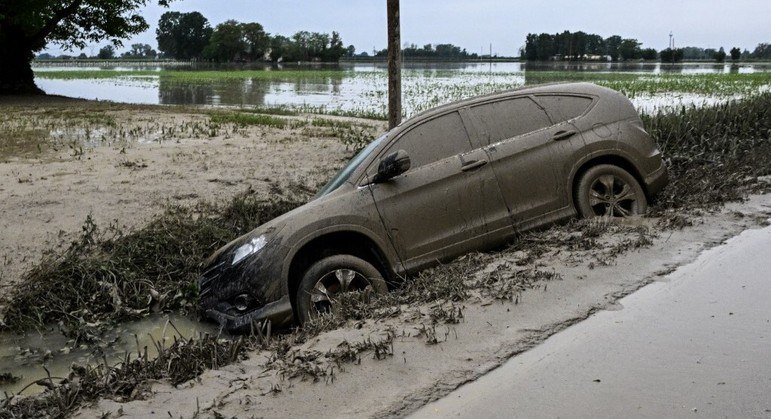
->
(383, 112, 471, 168)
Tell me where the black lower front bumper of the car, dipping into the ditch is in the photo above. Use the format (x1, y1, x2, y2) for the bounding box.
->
(204, 295, 293, 333)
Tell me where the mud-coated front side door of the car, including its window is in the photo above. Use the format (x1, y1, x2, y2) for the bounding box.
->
(367, 111, 510, 270)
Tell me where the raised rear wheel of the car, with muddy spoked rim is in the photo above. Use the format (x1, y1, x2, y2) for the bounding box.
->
(575, 164, 648, 218)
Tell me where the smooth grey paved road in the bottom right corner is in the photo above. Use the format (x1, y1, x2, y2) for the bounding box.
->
(414, 227, 771, 418)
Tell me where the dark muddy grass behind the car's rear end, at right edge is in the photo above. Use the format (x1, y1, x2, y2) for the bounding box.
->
(643, 93, 771, 210)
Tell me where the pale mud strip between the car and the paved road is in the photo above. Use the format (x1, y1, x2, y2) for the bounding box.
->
(78, 195, 771, 417)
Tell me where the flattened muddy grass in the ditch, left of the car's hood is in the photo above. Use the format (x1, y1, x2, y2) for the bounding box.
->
(2, 190, 307, 341)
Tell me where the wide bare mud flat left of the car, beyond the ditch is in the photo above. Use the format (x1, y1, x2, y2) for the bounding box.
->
(0, 97, 384, 304)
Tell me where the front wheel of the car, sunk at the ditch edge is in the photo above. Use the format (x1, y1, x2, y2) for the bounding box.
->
(297, 255, 388, 324)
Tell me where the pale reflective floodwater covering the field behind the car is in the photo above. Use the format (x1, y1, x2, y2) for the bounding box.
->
(34, 62, 771, 117)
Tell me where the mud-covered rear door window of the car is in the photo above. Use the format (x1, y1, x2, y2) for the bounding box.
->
(471, 97, 551, 144)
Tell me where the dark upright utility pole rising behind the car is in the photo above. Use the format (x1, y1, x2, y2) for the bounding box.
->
(387, 0, 402, 129)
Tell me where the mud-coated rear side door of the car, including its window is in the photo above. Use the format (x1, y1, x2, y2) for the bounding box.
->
(469, 96, 564, 229)
